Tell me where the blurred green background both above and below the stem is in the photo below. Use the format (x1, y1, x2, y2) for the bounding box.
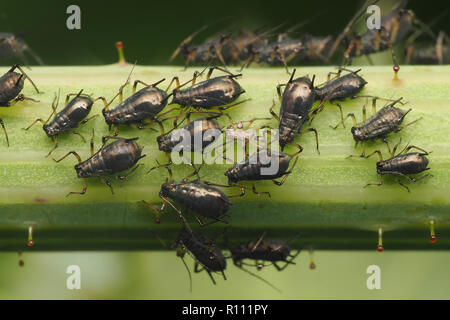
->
(0, 0, 450, 299)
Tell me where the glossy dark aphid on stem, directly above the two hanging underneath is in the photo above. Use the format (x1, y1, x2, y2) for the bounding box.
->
(142, 163, 245, 226)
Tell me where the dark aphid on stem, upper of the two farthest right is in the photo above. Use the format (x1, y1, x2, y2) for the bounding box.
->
(334, 98, 419, 157)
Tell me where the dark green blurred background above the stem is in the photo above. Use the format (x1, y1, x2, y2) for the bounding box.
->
(0, 0, 450, 65)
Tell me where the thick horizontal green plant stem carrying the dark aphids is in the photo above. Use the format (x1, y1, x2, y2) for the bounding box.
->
(0, 66, 450, 251)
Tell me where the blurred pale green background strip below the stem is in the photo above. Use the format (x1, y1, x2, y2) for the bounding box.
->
(0, 250, 450, 299)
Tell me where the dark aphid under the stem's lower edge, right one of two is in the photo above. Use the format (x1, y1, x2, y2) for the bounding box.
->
(229, 233, 300, 271)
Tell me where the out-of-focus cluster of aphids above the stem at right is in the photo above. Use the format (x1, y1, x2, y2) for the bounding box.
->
(170, 0, 450, 73)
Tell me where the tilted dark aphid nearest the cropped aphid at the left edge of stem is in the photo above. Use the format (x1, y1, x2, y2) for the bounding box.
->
(25, 90, 95, 157)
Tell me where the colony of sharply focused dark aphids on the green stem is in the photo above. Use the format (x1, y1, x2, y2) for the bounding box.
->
(0, 60, 429, 286)
